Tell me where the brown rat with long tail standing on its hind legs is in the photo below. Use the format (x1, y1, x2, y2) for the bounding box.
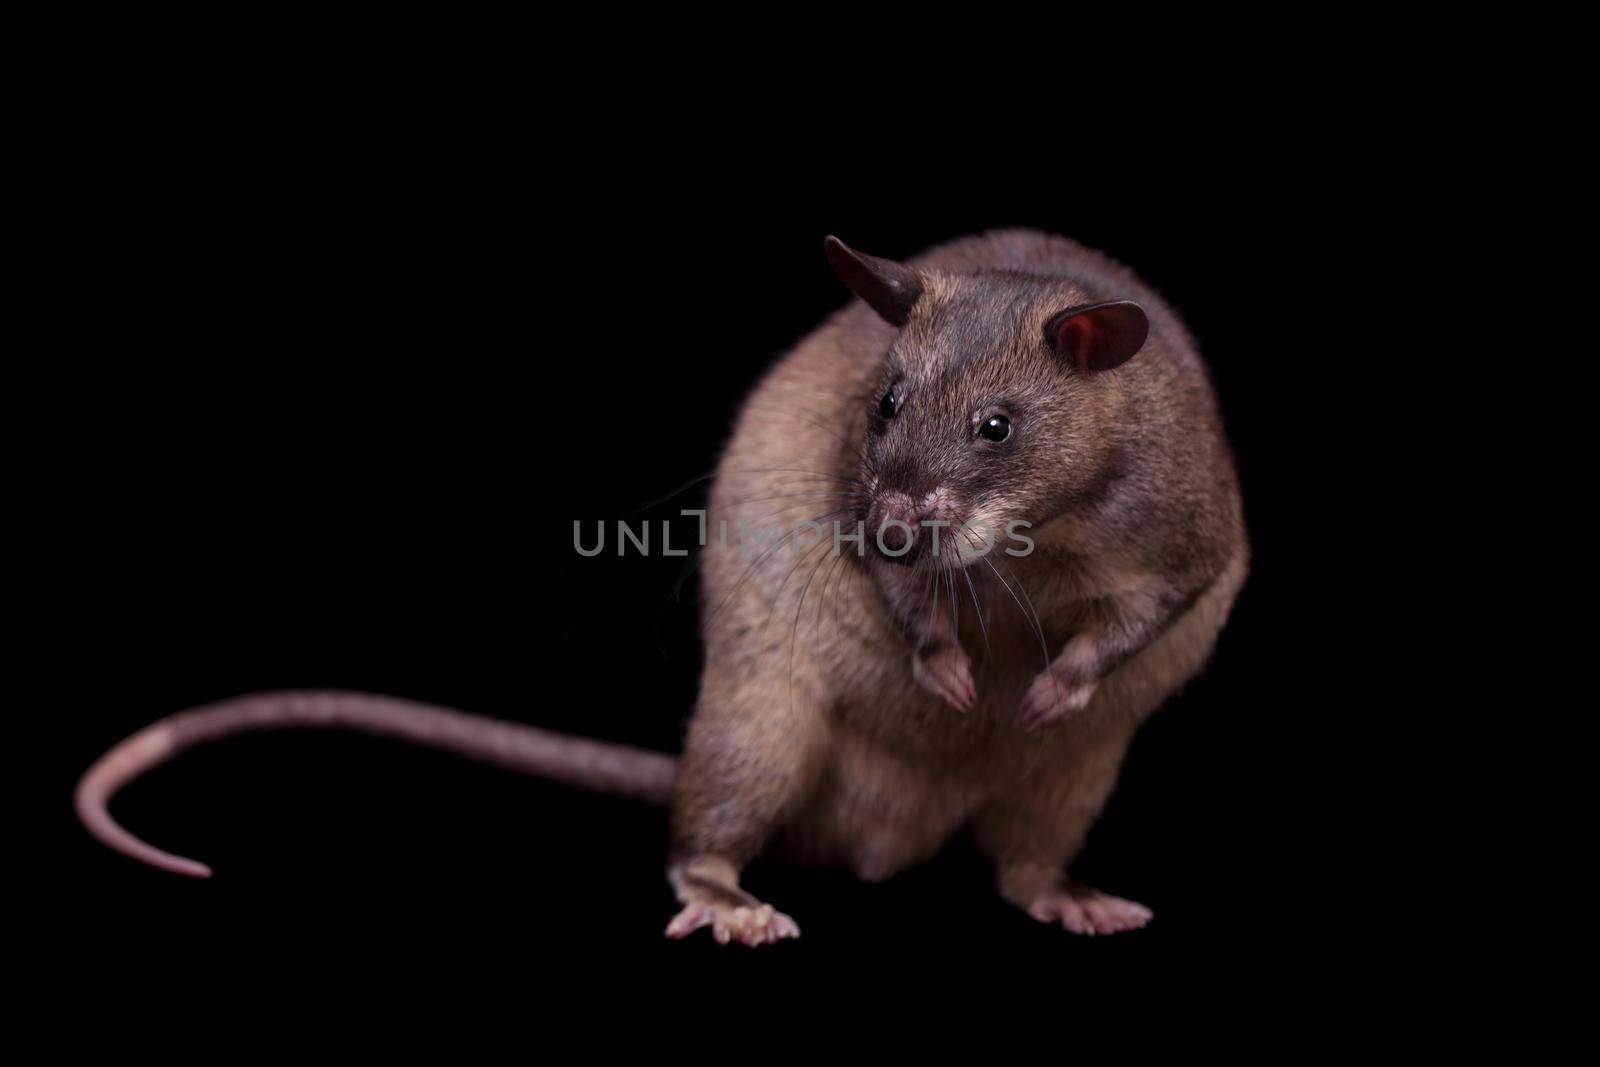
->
(77, 230, 1250, 945)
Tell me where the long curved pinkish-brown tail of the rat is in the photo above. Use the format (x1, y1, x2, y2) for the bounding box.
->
(77, 689, 677, 878)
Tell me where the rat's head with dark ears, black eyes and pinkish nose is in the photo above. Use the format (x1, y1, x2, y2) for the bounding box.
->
(827, 237, 1149, 565)
